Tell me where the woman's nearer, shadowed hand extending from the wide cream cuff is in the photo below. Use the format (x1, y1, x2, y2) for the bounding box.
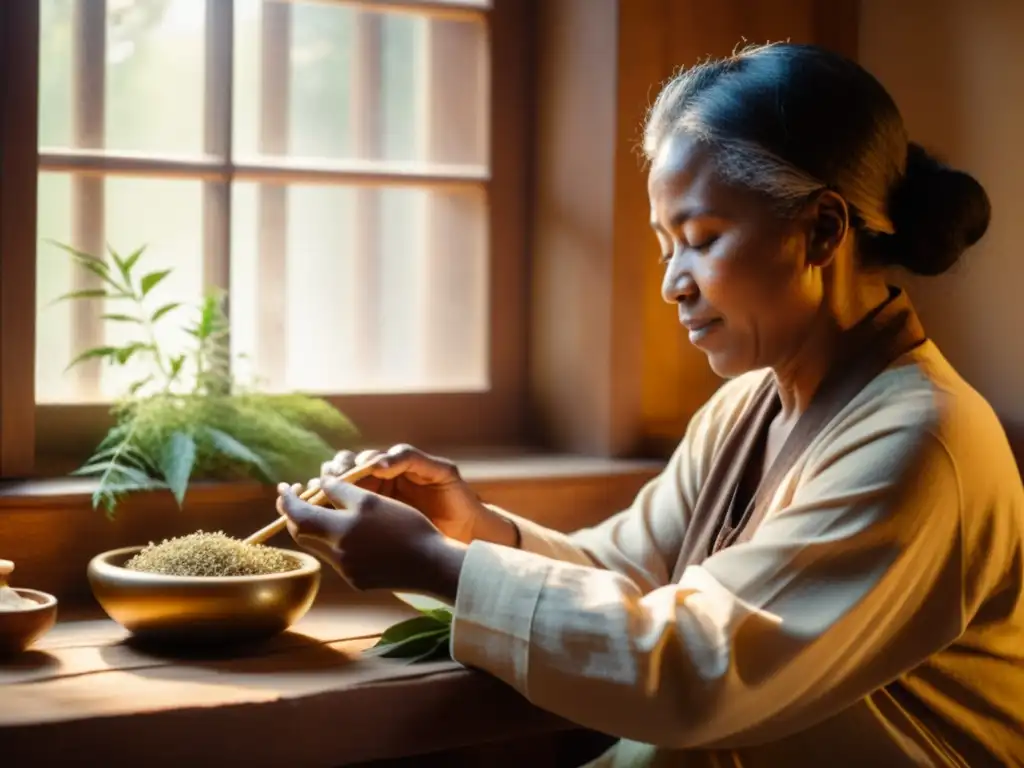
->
(278, 475, 466, 602)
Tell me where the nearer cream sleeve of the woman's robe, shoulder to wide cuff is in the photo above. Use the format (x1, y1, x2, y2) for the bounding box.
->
(453, 415, 964, 749)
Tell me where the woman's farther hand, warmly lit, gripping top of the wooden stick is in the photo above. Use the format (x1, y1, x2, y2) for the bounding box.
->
(301, 445, 518, 546)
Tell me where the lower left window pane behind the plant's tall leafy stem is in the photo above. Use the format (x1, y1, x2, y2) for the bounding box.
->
(36, 173, 203, 402)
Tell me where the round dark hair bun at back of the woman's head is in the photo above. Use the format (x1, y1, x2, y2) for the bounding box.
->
(879, 141, 991, 275)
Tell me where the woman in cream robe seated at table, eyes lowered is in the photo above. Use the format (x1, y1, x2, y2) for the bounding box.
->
(279, 45, 1024, 767)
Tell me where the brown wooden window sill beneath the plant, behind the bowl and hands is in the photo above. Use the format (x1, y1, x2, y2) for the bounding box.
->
(0, 455, 664, 609)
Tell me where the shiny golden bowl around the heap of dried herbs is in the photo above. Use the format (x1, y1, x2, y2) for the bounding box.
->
(87, 547, 321, 645)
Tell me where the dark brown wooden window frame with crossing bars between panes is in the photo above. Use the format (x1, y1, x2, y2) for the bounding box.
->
(0, 0, 532, 477)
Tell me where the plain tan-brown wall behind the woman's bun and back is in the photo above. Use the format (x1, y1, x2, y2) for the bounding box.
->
(859, 0, 1024, 469)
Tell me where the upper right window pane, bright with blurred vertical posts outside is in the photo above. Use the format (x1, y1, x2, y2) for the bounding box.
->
(234, 0, 488, 165)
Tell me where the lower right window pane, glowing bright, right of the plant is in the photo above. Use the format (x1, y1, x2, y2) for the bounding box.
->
(231, 183, 488, 393)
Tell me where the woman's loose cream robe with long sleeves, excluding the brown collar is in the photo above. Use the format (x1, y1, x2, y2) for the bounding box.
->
(452, 342, 1024, 768)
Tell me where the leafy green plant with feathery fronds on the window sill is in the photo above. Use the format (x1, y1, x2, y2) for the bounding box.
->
(48, 243, 356, 516)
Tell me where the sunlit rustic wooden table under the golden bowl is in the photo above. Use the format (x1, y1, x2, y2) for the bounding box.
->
(0, 596, 571, 768)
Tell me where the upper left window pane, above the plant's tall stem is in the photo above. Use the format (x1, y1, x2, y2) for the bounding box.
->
(39, 0, 206, 155)
